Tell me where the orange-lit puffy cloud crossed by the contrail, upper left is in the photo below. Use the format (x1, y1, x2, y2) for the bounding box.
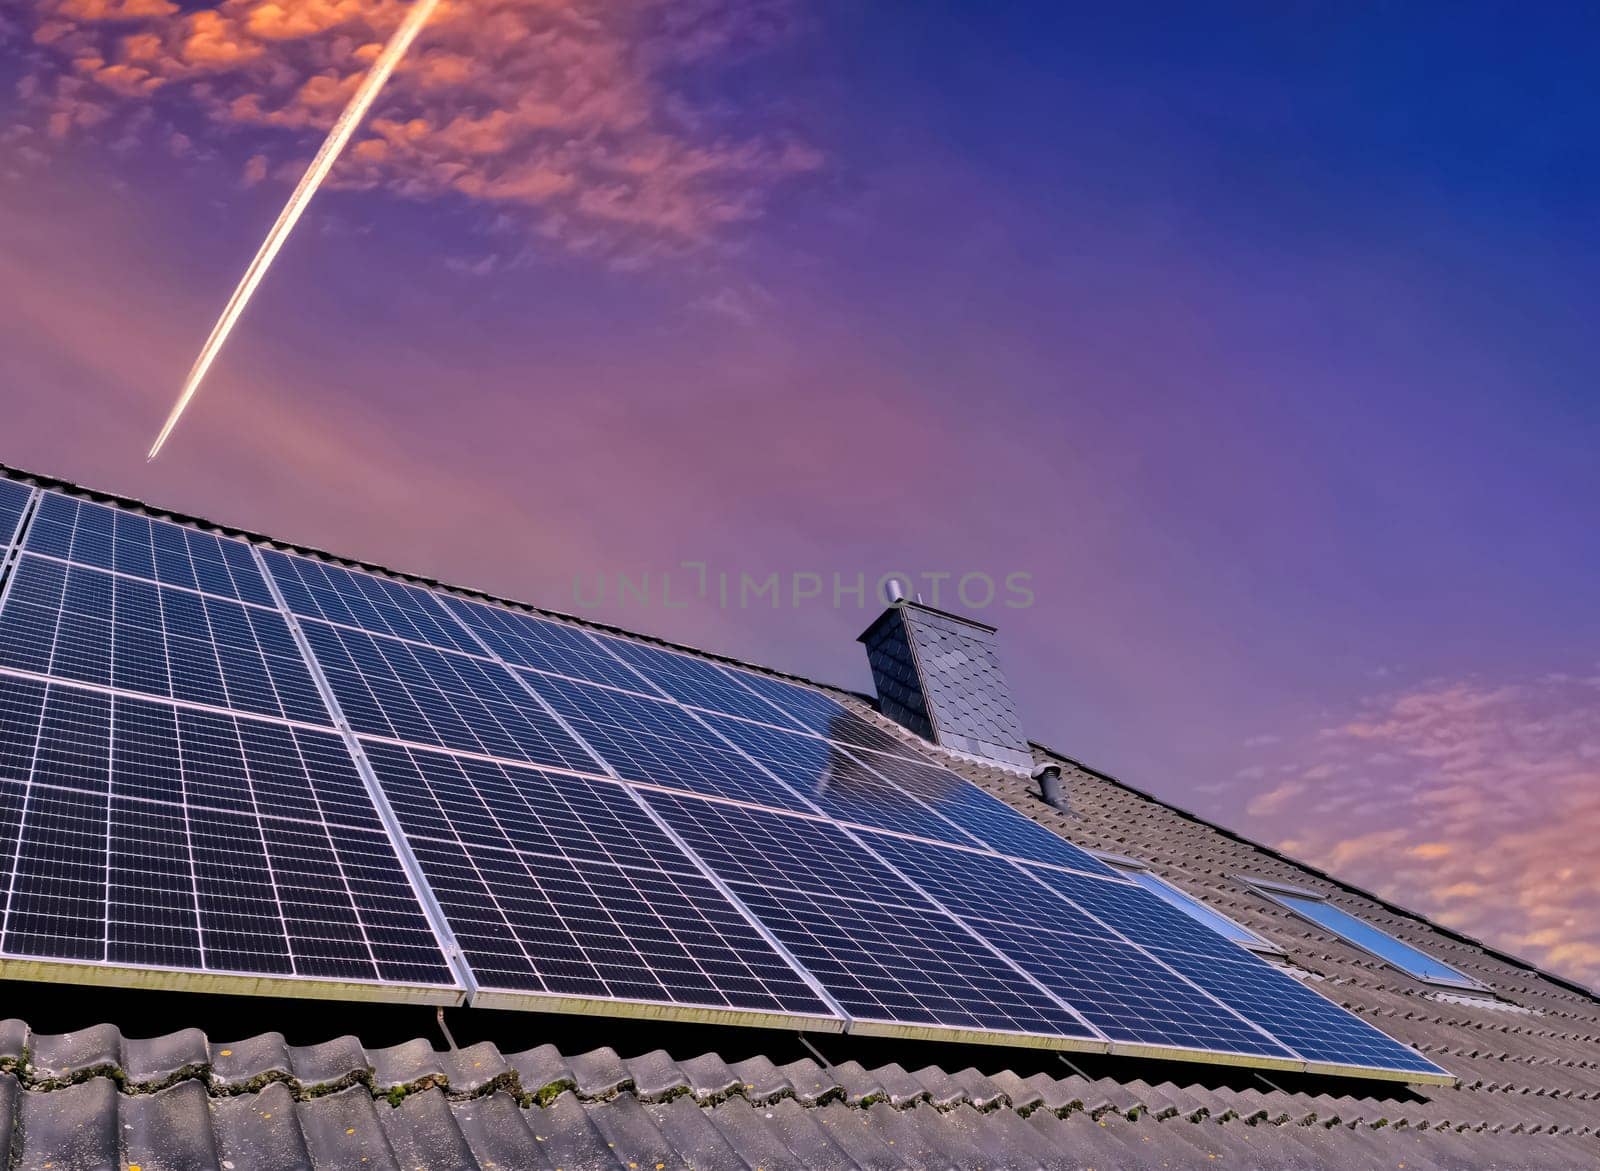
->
(24, 0, 824, 266)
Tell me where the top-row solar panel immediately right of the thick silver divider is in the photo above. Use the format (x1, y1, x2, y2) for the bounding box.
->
(262, 549, 483, 654)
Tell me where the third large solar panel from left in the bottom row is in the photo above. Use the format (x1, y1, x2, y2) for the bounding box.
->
(645, 792, 1091, 1038)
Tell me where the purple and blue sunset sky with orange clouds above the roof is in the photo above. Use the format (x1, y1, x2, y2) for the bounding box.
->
(0, 0, 1600, 985)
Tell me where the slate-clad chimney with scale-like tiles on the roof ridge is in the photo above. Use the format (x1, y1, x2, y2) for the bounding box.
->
(859, 597, 1034, 769)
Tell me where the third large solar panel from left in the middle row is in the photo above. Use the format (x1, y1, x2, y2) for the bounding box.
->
(525, 673, 805, 809)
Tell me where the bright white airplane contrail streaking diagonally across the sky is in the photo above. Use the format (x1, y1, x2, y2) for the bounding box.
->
(146, 0, 438, 461)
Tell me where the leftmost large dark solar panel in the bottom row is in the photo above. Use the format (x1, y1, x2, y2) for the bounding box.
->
(0, 678, 454, 987)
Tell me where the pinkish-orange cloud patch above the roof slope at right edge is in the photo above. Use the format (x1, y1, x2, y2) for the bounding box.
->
(1246, 675, 1600, 985)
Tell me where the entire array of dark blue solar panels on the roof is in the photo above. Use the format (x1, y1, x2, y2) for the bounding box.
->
(0, 480, 1448, 1080)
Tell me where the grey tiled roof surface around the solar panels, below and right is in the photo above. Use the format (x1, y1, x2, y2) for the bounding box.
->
(0, 469, 1600, 1171)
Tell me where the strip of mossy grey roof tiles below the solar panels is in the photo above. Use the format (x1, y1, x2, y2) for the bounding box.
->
(0, 1021, 1597, 1171)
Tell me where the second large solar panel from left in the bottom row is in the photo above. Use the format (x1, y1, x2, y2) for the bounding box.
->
(366, 744, 830, 1016)
